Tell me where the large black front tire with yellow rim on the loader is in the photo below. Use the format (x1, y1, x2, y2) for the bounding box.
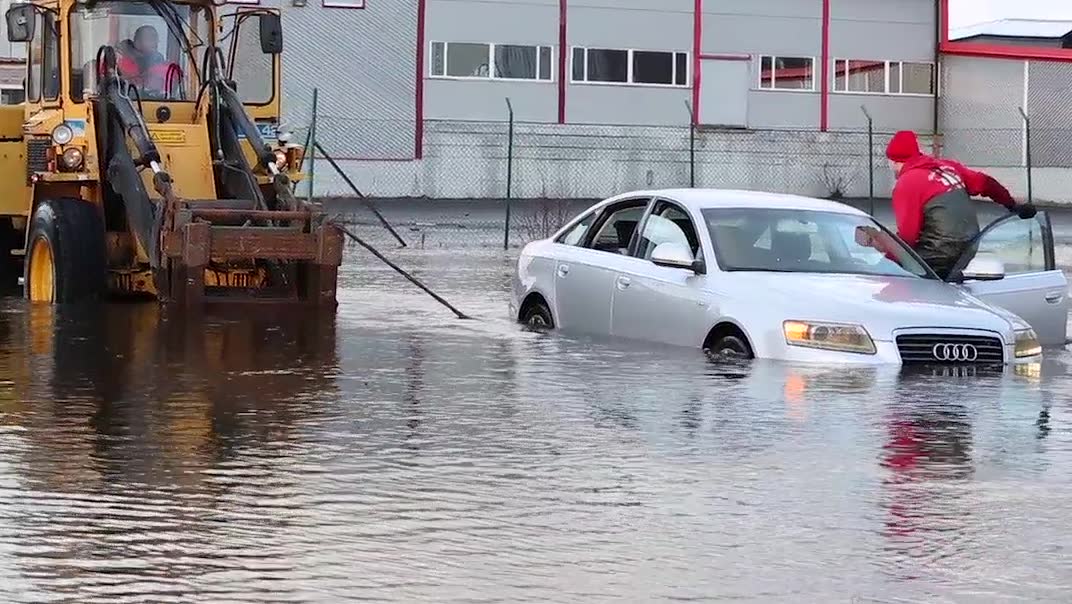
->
(24, 198, 108, 304)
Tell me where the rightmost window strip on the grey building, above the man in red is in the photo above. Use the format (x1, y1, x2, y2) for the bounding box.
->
(834, 59, 935, 97)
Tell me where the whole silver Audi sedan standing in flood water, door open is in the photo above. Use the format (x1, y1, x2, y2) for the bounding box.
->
(511, 190, 1068, 365)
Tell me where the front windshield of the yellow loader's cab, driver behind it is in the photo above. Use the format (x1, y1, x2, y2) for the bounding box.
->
(71, 0, 211, 100)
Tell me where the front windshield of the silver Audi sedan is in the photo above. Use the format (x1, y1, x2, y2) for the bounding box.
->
(703, 208, 932, 278)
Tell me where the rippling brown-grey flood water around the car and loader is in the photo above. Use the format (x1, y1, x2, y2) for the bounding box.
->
(0, 207, 1072, 603)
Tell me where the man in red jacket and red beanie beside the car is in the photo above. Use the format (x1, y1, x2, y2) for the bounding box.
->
(885, 130, 1036, 279)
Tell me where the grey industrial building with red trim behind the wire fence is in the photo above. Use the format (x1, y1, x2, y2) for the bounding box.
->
(0, 0, 1072, 200)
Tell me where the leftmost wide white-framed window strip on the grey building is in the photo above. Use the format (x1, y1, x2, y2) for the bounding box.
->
(431, 42, 552, 82)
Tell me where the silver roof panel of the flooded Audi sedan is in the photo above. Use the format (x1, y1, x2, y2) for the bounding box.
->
(608, 189, 867, 216)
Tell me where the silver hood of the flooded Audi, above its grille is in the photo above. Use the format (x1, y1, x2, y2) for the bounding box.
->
(729, 272, 1015, 340)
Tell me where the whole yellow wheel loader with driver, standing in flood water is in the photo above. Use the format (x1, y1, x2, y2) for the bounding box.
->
(0, 0, 342, 306)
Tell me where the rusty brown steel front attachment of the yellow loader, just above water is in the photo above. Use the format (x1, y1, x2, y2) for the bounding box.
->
(158, 203, 343, 308)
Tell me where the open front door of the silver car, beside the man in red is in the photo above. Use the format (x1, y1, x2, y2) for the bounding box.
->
(953, 211, 1069, 345)
